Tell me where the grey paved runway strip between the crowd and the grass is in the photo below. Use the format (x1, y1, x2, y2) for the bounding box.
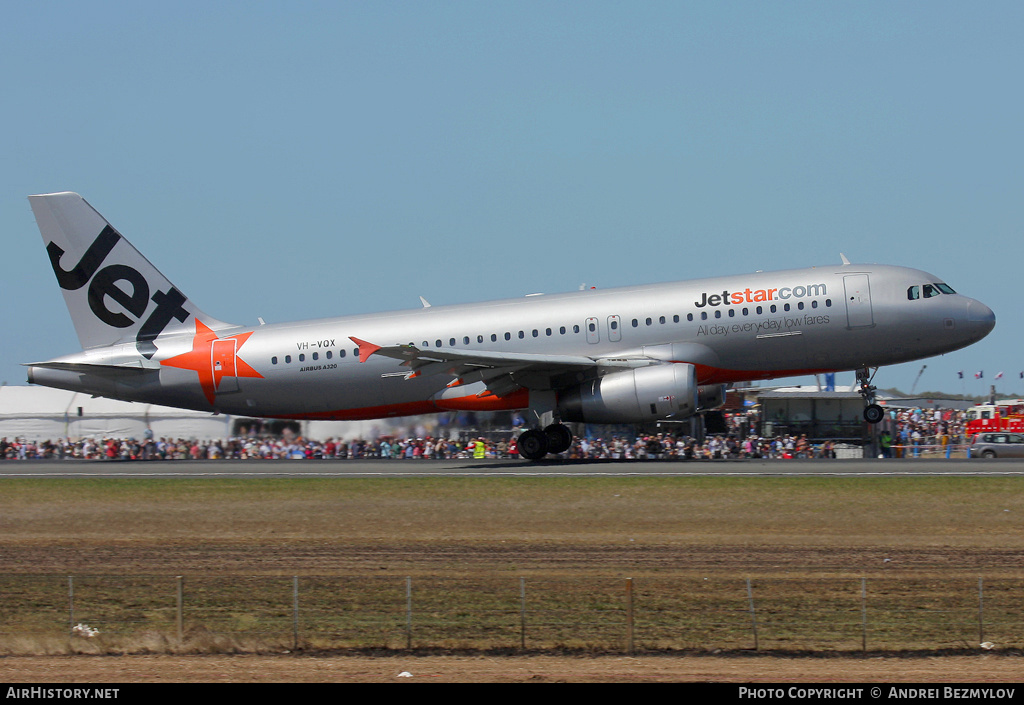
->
(0, 458, 1024, 479)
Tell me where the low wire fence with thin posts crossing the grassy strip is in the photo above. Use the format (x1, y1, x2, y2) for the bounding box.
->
(0, 575, 1024, 653)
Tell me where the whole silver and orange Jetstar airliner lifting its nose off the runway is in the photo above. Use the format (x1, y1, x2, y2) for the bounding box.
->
(29, 193, 995, 459)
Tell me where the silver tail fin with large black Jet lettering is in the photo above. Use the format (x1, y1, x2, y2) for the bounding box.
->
(29, 193, 229, 359)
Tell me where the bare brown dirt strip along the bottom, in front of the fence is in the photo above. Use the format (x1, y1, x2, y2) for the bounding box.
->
(0, 655, 1024, 685)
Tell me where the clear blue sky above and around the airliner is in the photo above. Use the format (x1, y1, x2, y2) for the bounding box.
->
(0, 0, 1024, 393)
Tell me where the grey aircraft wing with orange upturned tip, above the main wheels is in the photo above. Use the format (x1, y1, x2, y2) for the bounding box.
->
(351, 337, 650, 397)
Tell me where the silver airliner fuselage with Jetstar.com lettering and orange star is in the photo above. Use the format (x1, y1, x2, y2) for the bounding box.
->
(29, 264, 994, 419)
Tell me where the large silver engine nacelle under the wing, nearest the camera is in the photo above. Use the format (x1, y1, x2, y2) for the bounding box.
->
(558, 363, 697, 423)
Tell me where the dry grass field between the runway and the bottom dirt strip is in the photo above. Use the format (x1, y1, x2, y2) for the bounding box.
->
(0, 476, 1024, 653)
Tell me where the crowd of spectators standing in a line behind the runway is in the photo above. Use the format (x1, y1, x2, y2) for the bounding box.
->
(0, 408, 967, 460)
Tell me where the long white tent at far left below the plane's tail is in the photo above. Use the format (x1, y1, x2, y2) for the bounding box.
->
(0, 386, 231, 441)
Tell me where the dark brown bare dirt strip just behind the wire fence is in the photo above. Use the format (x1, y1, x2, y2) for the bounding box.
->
(0, 540, 1024, 577)
